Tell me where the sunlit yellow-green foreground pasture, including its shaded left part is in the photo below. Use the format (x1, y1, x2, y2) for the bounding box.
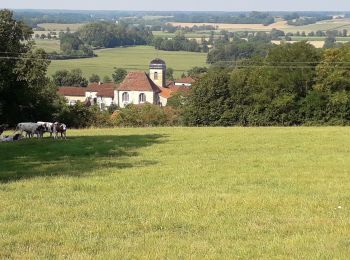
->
(0, 127, 350, 259)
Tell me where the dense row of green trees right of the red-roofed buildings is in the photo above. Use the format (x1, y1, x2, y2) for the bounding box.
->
(183, 42, 350, 126)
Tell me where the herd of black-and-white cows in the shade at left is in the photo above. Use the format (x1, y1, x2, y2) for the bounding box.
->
(0, 122, 67, 142)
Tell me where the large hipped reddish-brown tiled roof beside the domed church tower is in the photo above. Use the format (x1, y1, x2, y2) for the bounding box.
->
(118, 71, 160, 93)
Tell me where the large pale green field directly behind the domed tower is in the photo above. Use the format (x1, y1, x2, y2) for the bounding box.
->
(48, 46, 207, 78)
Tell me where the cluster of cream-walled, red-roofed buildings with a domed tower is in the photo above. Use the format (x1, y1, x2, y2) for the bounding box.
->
(58, 59, 194, 109)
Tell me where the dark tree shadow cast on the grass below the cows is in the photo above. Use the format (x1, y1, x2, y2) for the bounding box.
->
(0, 134, 164, 183)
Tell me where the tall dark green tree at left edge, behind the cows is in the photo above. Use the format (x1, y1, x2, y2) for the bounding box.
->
(0, 10, 62, 125)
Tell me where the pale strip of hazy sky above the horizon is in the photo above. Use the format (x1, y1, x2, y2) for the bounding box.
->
(0, 0, 350, 11)
